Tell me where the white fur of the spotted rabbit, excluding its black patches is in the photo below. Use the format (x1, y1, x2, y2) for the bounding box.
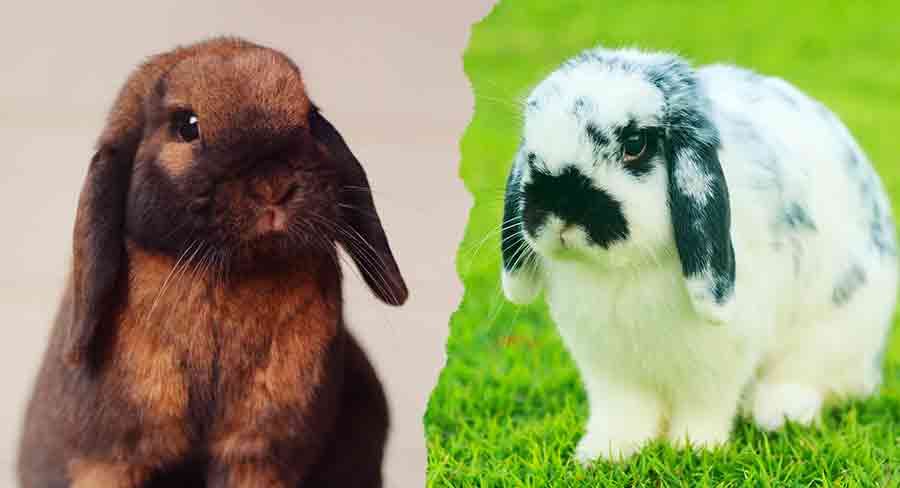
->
(503, 50, 897, 462)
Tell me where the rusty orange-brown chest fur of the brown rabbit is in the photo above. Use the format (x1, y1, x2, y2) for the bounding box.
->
(106, 244, 340, 435)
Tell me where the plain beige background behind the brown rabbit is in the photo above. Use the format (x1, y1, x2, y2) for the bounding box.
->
(0, 0, 491, 487)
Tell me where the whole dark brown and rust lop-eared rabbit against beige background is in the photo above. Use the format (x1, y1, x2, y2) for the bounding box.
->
(19, 38, 407, 488)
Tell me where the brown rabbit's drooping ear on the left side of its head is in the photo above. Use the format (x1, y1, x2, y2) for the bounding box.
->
(64, 147, 132, 363)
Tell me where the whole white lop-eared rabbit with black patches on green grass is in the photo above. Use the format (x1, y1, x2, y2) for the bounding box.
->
(502, 48, 898, 462)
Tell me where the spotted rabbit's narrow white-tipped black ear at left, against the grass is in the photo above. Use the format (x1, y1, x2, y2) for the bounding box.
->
(500, 152, 543, 305)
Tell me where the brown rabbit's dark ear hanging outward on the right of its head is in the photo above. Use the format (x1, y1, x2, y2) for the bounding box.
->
(310, 108, 409, 305)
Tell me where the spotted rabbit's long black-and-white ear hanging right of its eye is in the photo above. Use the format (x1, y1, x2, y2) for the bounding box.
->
(651, 58, 735, 323)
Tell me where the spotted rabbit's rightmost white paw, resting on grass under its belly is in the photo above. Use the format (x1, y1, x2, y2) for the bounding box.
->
(753, 383, 824, 431)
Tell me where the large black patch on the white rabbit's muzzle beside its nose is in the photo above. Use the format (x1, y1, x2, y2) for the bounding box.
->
(523, 166, 628, 248)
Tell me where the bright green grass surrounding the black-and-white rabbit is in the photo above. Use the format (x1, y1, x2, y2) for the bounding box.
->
(425, 0, 900, 487)
